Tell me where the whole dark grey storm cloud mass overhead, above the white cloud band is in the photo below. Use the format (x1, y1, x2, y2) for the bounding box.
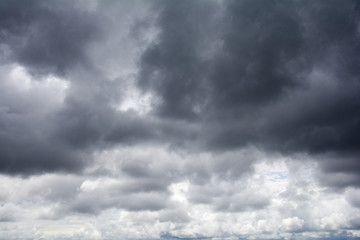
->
(0, 0, 360, 193)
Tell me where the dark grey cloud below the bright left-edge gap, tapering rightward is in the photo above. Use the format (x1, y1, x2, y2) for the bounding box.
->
(0, 73, 161, 174)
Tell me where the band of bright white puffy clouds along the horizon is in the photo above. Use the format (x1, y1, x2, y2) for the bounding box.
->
(0, 149, 360, 239)
